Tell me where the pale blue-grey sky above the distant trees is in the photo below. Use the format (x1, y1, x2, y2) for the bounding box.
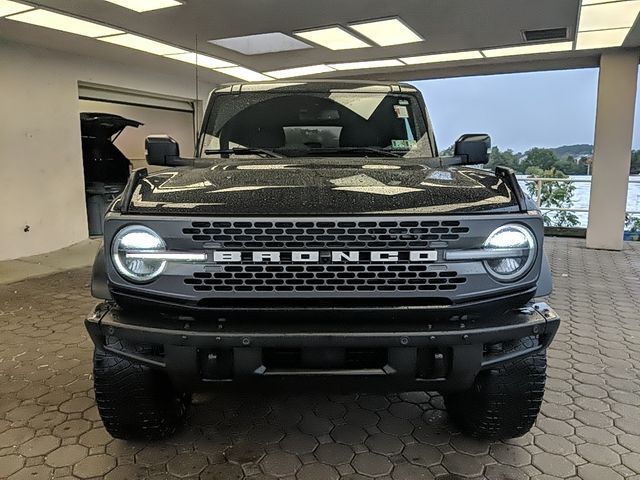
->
(410, 68, 640, 152)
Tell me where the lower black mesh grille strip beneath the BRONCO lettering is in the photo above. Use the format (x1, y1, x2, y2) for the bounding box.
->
(184, 264, 467, 293)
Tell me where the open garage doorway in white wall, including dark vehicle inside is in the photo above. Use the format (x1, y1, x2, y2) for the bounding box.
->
(78, 85, 196, 235)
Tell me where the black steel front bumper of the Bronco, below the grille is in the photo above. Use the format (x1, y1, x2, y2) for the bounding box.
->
(85, 302, 560, 391)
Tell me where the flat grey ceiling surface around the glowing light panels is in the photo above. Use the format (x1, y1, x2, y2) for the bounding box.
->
(0, 0, 640, 83)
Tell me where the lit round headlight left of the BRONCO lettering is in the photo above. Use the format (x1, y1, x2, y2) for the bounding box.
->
(111, 225, 167, 283)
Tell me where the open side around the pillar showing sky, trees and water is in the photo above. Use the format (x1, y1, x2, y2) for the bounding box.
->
(411, 68, 640, 230)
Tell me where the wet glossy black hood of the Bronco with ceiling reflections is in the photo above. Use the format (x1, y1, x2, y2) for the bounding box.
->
(129, 158, 519, 215)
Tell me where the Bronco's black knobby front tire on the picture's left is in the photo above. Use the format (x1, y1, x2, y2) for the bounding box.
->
(93, 339, 191, 440)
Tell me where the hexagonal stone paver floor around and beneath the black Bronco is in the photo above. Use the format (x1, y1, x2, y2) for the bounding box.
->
(0, 239, 640, 480)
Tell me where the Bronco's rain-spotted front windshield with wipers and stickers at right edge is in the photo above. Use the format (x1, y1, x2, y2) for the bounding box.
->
(200, 91, 434, 158)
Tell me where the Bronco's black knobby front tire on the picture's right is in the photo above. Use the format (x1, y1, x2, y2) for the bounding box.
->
(444, 337, 547, 440)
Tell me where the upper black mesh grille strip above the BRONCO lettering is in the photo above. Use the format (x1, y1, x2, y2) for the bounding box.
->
(182, 220, 469, 249)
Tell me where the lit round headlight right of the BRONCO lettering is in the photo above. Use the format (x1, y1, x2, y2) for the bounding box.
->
(483, 224, 536, 281)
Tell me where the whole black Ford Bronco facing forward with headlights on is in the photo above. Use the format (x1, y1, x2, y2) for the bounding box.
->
(86, 81, 559, 439)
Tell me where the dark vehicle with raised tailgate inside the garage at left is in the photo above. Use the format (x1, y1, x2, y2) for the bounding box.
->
(80, 112, 142, 235)
